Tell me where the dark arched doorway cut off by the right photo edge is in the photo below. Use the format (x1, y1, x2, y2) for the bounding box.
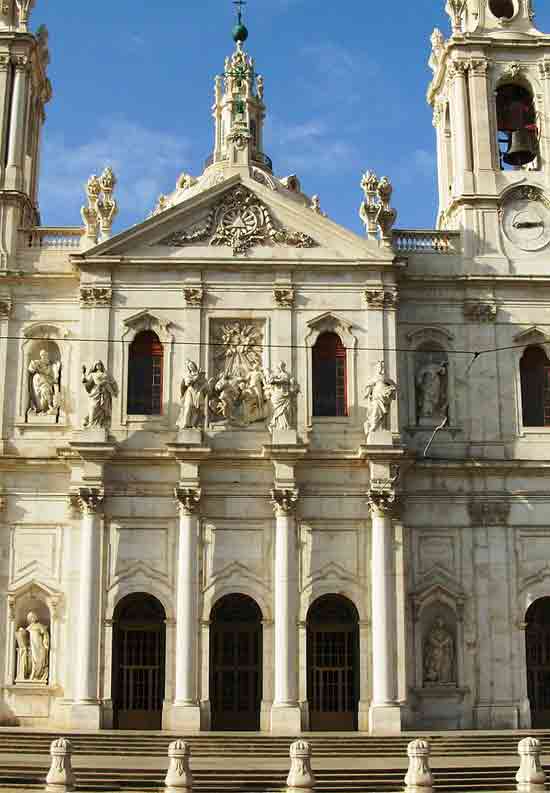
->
(525, 597, 550, 727)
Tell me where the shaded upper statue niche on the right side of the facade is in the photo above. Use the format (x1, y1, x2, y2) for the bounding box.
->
(415, 344, 449, 427)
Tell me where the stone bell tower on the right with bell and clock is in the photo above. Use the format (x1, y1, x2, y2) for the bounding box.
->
(428, 0, 550, 258)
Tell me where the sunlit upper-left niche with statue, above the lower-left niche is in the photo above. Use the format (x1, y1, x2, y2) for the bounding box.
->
(25, 341, 62, 423)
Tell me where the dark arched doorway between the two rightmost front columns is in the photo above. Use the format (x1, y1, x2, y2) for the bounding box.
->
(307, 595, 359, 730)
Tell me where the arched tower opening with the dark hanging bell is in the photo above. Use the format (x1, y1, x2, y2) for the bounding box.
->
(496, 83, 538, 169)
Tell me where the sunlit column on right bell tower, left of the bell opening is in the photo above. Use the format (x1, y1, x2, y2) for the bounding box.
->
(449, 60, 474, 196)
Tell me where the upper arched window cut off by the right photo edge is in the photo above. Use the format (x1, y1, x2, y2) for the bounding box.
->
(520, 347, 550, 427)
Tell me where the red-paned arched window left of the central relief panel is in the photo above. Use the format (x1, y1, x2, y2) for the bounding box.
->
(127, 330, 163, 416)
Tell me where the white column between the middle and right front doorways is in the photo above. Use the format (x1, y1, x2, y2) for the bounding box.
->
(271, 488, 301, 734)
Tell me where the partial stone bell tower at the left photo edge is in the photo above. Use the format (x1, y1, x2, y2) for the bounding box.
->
(0, 0, 52, 270)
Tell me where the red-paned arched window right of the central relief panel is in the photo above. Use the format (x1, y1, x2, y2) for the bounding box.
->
(312, 333, 348, 416)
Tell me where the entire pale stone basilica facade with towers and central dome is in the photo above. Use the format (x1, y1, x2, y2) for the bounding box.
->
(0, 0, 550, 734)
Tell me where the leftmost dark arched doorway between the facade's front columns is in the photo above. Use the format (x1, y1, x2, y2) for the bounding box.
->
(113, 592, 166, 730)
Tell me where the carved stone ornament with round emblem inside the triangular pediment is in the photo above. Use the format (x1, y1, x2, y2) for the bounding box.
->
(160, 185, 317, 256)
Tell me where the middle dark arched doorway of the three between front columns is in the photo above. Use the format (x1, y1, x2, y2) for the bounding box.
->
(210, 594, 262, 730)
